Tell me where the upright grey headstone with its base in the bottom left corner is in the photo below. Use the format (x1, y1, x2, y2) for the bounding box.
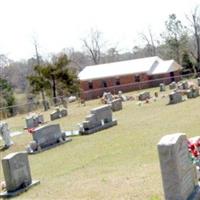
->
(0, 152, 39, 197)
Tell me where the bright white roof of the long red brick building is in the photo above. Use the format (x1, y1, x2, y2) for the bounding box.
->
(78, 56, 183, 80)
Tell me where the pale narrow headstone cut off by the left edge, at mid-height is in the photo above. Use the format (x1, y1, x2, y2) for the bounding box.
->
(0, 121, 13, 148)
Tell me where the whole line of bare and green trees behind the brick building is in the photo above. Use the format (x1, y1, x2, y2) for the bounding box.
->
(0, 6, 200, 114)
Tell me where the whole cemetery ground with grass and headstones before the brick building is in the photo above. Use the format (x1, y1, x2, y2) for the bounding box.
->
(0, 80, 200, 200)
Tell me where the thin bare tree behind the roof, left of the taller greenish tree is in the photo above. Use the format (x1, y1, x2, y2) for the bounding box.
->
(140, 28, 156, 56)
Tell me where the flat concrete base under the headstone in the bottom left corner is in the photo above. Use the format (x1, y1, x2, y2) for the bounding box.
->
(0, 180, 40, 198)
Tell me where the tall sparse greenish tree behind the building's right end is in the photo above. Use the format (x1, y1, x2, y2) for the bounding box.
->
(162, 14, 188, 64)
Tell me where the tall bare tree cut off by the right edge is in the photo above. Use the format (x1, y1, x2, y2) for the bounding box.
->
(186, 6, 200, 70)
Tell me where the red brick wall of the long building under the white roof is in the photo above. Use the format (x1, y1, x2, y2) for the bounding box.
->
(80, 71, 180, 100)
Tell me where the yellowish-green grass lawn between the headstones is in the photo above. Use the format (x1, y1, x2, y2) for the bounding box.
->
(0, 88, 200, 200)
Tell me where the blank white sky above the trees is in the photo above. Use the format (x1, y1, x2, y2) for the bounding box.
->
(0, 0, 200, 60)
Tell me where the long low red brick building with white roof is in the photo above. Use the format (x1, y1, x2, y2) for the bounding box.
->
(78, 56, 182, 100)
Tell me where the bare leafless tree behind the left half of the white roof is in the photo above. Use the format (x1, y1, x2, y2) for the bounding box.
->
(82, 30, 103, 64)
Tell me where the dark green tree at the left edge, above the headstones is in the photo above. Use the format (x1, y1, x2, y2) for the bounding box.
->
(0, 78, 15, 115)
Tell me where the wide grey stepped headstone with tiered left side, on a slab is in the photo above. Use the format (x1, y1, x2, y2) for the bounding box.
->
(79, 105, 117, 135)
